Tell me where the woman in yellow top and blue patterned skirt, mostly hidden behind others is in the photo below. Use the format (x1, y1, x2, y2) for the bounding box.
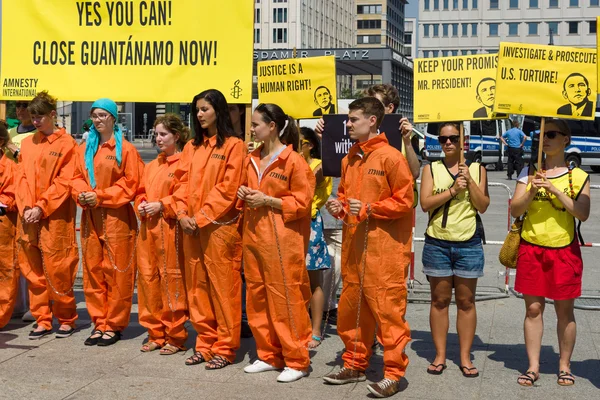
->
(300, 128, 335, 348)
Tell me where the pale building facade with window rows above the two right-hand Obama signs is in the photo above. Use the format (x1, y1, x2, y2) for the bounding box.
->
(418, 0, 600, 57)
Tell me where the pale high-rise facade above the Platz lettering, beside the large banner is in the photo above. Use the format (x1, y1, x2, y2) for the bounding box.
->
(254, 0, 354, 49)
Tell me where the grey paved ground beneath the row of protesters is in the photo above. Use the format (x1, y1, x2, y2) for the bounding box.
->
(0, 149, 600, 400)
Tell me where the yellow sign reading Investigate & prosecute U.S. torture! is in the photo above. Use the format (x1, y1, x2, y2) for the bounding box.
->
(494, 43, 598, 120)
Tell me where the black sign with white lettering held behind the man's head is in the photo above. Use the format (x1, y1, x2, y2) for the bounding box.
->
(321, 114, 402, 176)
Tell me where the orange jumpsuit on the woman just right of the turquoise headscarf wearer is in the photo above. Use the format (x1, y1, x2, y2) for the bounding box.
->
(134, 153, 188, 349)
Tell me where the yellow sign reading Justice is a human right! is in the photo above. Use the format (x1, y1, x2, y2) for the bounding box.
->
(257, 56, 337, 118)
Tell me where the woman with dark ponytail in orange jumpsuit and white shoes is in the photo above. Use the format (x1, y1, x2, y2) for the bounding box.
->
(238, 104, 316, 382)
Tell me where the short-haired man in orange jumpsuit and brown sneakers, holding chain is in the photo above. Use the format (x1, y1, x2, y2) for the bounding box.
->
(324, 97, 413, 397)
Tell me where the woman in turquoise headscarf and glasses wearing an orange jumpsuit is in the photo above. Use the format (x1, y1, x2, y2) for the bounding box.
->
(71, 99, 144, 346)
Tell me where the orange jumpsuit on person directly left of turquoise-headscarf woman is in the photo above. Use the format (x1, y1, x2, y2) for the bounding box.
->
(17, 129, 79, 329)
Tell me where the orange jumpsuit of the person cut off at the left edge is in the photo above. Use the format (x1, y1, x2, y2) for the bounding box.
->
(0, 153, 19, 329)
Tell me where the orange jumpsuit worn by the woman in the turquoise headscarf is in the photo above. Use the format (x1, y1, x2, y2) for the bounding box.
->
(71, 138, 144, 332)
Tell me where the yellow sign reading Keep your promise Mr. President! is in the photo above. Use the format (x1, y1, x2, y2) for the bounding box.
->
(414, 54, 506, 122)
